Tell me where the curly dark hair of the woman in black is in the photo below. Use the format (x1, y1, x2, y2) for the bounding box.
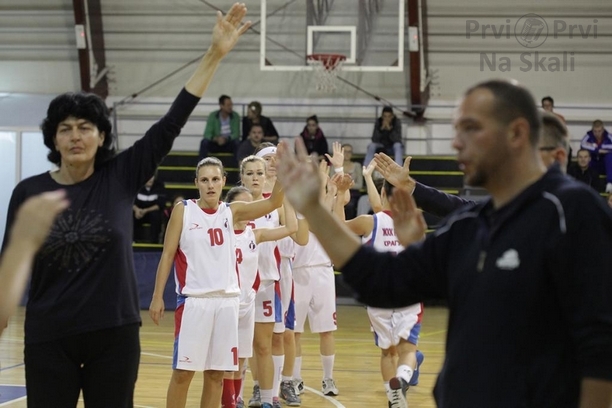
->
(40, 92, 116, 168)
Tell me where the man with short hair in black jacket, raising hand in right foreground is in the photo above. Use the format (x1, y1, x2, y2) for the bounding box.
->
(277, 81, 612, 408)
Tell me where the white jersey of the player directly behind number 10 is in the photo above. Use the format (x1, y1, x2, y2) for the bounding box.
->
(235, 225, 259, 303)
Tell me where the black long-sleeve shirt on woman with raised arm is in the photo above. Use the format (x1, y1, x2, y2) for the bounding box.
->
(4, 90, 199, 343)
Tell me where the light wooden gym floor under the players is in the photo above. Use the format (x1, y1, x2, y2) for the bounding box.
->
(0, 305, 448, 408)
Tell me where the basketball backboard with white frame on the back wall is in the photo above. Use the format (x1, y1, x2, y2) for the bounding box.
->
(260, 0, 405, 72)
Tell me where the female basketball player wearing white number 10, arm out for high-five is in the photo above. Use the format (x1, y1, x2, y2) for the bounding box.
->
(149, 157, 283, 408)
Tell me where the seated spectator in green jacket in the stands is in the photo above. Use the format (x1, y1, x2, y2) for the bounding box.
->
(200, 95, 240, 160)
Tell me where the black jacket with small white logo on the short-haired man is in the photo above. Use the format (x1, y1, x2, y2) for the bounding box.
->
(342, 168, 612, 408)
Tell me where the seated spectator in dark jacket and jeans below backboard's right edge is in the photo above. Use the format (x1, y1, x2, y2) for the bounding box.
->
(363, 106, 404, 166)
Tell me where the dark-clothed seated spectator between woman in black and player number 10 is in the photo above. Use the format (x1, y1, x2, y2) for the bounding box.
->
(132, 176, 166, 244)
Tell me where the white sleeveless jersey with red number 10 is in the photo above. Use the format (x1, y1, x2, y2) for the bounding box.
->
(174, 200, 240, 297)
